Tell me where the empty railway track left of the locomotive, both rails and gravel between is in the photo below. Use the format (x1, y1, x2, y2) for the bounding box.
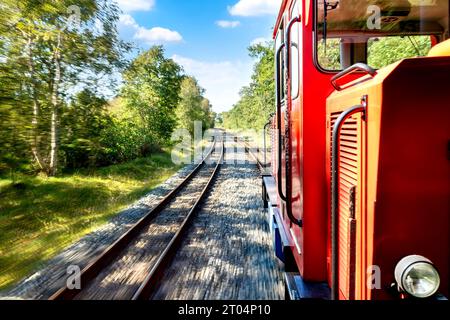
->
(50, 139, 224, 300)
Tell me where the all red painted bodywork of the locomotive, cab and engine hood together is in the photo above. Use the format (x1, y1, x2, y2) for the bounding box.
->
(273, 0, 450, 299)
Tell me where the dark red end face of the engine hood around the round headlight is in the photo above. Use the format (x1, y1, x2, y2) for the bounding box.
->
(373, 58, 450, 298)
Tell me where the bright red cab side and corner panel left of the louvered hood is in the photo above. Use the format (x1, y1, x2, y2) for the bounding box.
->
(272, 0, 333, 281)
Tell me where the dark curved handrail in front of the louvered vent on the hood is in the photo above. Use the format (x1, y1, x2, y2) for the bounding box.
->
(331, 102, 367, 300)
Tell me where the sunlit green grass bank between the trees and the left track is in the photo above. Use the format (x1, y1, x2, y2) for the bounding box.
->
(0, 152, 180, 290)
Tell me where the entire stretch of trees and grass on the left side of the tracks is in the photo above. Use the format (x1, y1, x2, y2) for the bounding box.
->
(0, 0, 215, 290)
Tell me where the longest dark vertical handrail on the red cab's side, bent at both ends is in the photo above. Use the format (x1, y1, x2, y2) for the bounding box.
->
(284, 16, 303, 227)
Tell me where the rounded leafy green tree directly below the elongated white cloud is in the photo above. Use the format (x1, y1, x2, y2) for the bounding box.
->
(121, 46, 183, 144)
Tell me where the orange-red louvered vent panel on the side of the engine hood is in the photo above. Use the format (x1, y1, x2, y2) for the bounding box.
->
(330, 113, 360, 298)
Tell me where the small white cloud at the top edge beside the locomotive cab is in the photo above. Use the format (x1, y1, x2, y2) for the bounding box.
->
(228, 0, 282, 17)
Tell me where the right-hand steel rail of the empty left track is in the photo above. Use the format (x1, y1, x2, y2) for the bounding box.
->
(132, 141, 225, 300)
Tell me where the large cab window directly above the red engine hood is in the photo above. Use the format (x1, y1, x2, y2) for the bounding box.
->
(315, 0, 449, 71)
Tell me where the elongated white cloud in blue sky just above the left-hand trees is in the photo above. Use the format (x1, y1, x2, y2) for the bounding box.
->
(119, 14, 183, 45)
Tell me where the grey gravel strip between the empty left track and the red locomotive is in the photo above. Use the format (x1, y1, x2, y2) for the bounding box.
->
(144, 135, 282, 300)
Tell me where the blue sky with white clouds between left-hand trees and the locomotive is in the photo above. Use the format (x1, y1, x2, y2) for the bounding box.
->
(117, 0, 281, 112)
